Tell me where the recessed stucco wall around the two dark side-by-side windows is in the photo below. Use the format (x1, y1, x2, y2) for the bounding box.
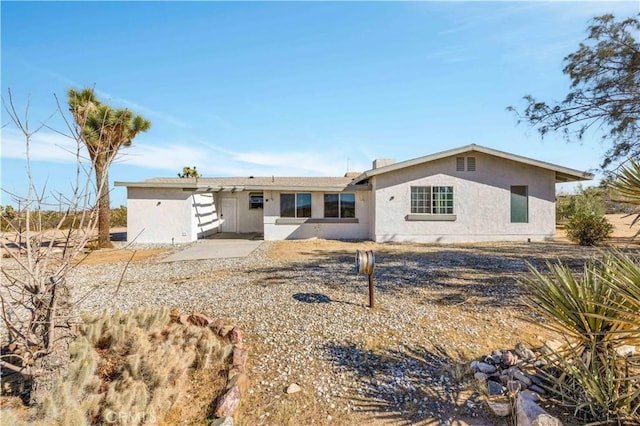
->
(264, 191, 371, 241)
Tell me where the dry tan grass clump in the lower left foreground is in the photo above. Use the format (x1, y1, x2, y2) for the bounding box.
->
(3, 308, 232, 426)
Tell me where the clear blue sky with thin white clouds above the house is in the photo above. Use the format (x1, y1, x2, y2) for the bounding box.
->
(0, 1, 639, 206)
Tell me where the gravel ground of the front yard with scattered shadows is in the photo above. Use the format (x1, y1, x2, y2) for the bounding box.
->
(1, 242, 592, 425)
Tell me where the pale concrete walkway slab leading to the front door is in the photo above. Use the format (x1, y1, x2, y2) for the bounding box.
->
(162, 239, 262, 262)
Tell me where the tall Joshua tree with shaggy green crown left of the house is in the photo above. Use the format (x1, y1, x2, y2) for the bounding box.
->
(68, 88, 151, 248)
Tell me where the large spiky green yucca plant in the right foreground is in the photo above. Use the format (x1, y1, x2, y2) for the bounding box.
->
(521, 252, 640, 424)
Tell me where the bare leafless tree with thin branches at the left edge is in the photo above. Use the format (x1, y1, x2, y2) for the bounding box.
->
(0, 91, 107, 404)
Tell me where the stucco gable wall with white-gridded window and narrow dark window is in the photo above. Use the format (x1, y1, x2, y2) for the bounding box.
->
(372, 152, 555, 242)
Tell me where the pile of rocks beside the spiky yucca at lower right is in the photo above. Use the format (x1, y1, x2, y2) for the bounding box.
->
(471, 343, 562, 425)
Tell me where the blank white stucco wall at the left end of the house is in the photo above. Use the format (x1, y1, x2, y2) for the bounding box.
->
(127, 188, 194, 243)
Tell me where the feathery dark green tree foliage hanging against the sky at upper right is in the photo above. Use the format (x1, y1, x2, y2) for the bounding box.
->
(508, 14, 640, 168)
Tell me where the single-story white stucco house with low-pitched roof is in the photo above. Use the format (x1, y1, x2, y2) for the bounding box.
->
(115, 145, 593, 243)
